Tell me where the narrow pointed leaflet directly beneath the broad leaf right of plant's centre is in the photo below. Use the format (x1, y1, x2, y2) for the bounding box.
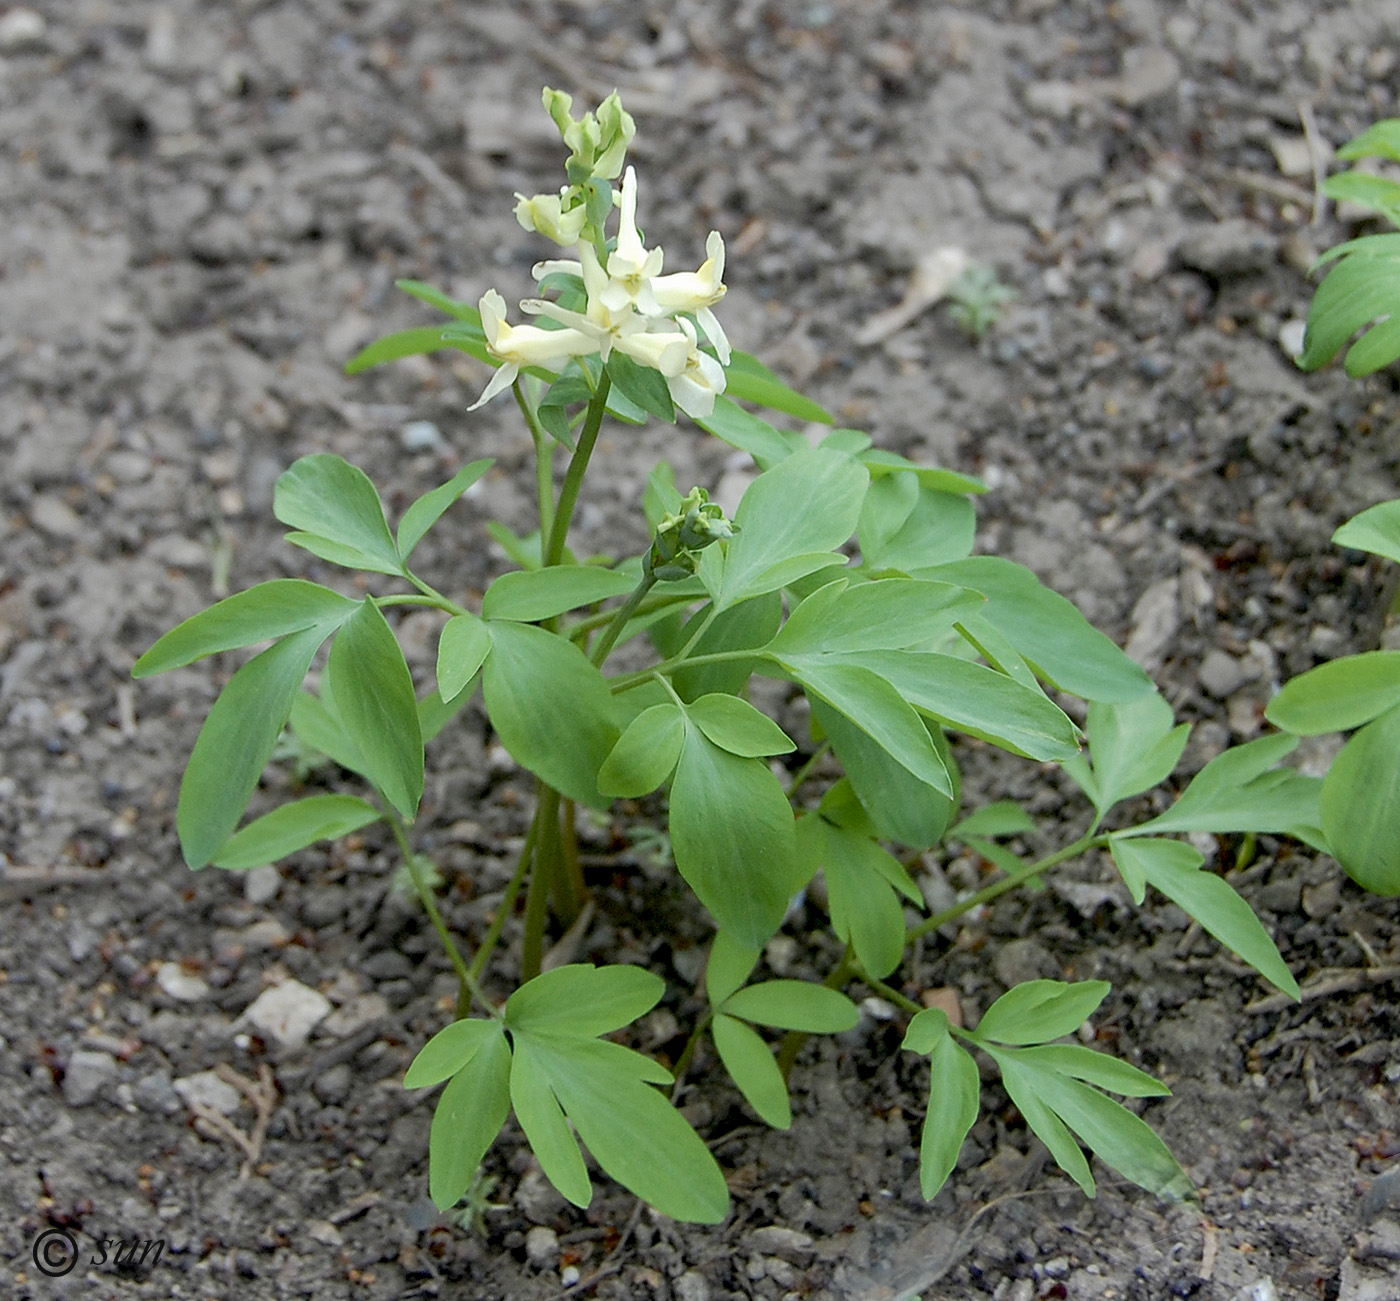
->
(846, 650, 1079, 760)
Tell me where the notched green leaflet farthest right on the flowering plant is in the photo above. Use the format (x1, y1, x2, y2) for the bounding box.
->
(1123, 734, 1322, 836)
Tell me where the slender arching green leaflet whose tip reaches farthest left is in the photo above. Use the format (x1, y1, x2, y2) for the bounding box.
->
(132, 578, 360, 678)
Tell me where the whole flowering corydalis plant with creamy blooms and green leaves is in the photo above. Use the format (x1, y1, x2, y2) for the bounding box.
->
(134, 91, 1317, 1221)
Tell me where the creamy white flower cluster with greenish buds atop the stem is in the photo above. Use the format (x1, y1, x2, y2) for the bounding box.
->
(472, 91, 729, 419)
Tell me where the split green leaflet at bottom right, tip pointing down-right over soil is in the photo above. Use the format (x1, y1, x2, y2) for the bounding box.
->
(993, 1049, 1194, 1202)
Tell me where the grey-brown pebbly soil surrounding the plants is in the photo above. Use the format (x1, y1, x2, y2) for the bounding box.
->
(0, 0, 1400, 1301)
